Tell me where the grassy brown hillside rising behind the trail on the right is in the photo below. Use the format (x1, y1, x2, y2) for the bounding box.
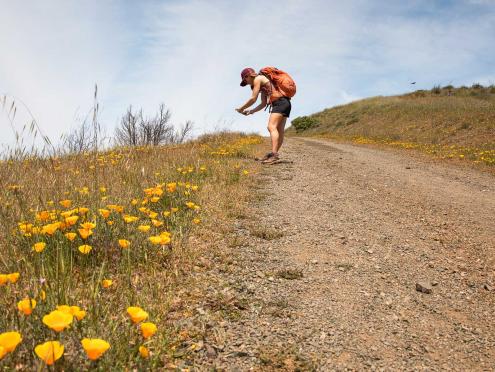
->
(292, 84, 495, 163)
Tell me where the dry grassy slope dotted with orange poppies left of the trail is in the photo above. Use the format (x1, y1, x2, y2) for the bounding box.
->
(0, 134, 260, 370)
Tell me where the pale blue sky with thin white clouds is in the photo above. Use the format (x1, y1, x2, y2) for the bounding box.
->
(0, 0, 495, 145)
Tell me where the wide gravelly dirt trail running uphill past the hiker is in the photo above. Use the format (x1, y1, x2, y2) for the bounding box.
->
(192, 138, 495, 371)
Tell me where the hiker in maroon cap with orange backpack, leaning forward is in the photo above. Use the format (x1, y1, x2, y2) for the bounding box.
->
(236, 67, 296, 164)
